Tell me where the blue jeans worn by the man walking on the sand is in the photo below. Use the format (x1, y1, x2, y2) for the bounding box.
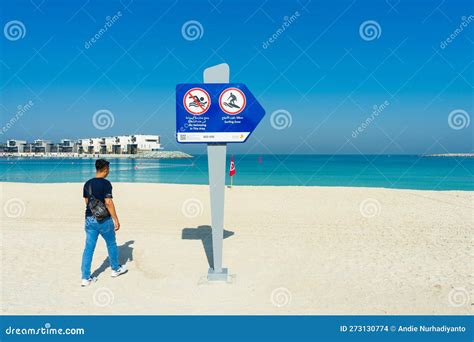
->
(81, 216, 119, 279)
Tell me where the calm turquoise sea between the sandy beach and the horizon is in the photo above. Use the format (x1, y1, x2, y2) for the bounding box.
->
(0, 155, 474, 190)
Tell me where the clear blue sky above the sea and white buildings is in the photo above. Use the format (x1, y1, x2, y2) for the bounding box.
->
(0, 0, 474, 154)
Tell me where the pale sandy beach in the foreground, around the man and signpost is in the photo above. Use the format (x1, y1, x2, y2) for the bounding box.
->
(0, 183, 474, 315)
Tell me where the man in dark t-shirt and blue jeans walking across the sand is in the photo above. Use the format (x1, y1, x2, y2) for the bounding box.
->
(81, 159, 127, 286)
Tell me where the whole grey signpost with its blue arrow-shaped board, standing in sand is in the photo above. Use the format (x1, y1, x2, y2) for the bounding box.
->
(176, 63, 265, 281)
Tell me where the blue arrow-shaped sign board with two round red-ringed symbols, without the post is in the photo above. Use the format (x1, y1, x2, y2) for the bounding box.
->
(176, 83, 265, 143)
